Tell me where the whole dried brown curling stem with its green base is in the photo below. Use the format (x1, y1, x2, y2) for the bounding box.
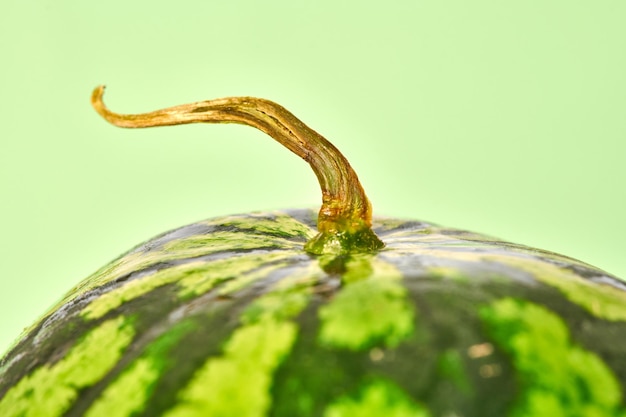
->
(91, 86, 384, 254)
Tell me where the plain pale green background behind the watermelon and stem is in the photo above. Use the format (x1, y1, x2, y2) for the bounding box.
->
(0, 0, 626, 351)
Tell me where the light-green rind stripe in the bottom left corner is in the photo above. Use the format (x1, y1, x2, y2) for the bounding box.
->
(0, 317, 134, 417)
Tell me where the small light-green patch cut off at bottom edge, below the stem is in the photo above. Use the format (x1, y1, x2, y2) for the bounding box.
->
(324, 379, 430, 417)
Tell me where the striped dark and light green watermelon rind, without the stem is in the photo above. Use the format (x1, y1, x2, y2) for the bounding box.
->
(0, 210, 626, 417)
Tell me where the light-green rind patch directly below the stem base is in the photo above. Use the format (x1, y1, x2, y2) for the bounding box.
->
(319, 259, 415, 351)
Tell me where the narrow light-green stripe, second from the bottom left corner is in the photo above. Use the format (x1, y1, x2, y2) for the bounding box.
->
(85, 322, 195, 417)
